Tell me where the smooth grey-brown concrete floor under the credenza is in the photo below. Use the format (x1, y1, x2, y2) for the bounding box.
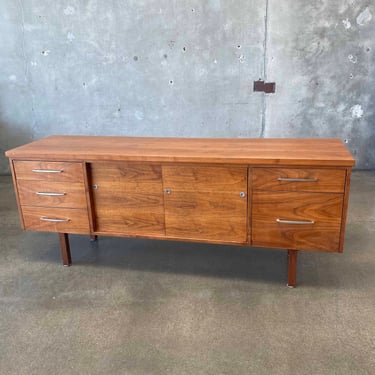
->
(0, 172, 375, 375)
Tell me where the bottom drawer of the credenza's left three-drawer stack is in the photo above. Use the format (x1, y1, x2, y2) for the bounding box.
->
(22, 206, 90, 234)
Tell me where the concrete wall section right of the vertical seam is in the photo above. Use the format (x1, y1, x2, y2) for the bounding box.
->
(265, 0, 375, 168)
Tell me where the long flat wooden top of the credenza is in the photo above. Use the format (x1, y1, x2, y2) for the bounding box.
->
(6, 136, 355, 167)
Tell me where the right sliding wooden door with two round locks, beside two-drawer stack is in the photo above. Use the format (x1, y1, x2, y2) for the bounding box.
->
(163, 165, 247, 243)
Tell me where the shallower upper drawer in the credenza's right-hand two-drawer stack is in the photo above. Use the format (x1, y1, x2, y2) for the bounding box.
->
(252, 168, 346, 193)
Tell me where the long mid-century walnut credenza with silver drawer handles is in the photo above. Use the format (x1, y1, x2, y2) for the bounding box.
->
(6, 136, 355, 287)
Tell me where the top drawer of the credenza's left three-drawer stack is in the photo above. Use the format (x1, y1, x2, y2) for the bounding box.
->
(14, 160, 83, 182)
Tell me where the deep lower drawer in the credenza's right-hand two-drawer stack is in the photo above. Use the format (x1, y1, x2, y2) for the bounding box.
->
(252, 191, 343, 251)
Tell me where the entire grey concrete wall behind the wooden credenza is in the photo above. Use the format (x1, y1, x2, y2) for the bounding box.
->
(0, 0, 375, 173)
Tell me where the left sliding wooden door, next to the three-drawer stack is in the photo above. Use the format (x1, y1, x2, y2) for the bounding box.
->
(91, 162, 165, 236)
